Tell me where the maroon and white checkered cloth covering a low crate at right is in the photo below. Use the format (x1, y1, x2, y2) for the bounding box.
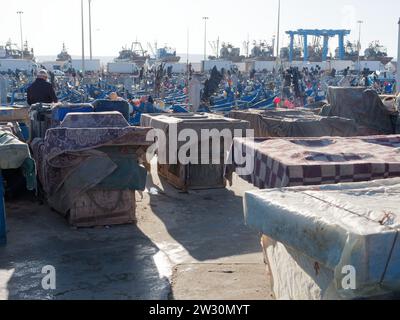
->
(225, 135, 400, 189)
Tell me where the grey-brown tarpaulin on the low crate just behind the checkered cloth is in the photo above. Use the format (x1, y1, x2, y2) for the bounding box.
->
(229, 109, 357, 137)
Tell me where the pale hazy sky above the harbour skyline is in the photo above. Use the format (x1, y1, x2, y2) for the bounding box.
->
(0, 0, 400, 56)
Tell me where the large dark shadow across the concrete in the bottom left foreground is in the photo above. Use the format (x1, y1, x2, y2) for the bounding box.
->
(0, 201, 170, 300)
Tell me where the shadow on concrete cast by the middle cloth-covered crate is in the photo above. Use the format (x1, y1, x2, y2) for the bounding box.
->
(147, 171, 261, 262)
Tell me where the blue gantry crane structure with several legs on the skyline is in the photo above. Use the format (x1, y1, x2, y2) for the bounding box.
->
(286, 29, 350, 62)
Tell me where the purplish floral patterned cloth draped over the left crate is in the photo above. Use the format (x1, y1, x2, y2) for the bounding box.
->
(31, 112, 152, 212)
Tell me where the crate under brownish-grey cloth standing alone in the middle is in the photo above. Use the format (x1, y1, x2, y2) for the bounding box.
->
(141, 113, 249, 190)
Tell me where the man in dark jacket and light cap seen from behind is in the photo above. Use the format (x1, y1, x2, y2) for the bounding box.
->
(27, 70, 58, 105)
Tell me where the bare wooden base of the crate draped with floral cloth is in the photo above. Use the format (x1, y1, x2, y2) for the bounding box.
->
(68, 190, 136, 227)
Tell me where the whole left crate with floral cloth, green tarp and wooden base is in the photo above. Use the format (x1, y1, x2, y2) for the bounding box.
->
(32, 112, 151, 226)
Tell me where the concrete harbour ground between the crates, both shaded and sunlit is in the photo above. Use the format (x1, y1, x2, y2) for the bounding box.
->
(0, 160, 272, 300)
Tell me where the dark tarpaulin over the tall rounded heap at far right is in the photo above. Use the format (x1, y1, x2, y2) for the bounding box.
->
(320, 87, 395, 134)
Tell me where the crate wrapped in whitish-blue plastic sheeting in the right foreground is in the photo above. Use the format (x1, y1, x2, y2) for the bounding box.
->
(244, 178, 400, 299)
